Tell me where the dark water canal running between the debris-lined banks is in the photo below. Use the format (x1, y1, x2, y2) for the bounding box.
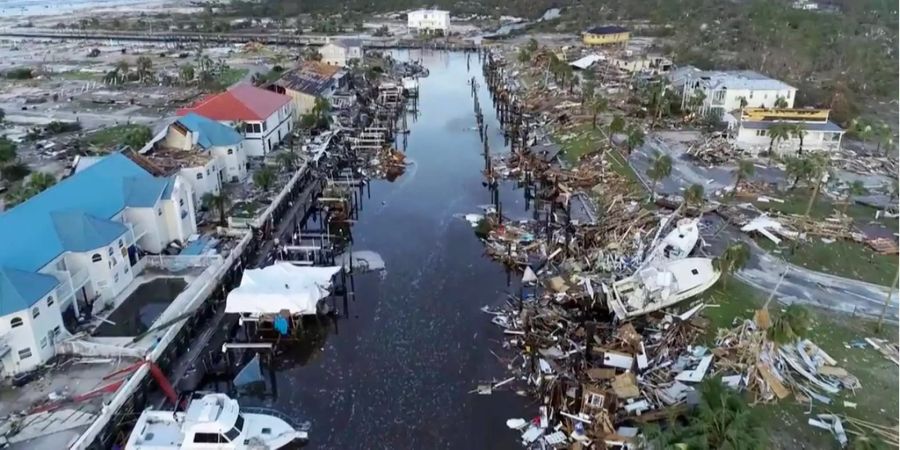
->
(242, 51, 536, 449)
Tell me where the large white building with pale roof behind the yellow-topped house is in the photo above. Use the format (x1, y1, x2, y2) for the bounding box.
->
(669, 66, 797, 115)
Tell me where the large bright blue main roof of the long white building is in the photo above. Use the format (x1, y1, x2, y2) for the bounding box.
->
(0, 153, 160, 272)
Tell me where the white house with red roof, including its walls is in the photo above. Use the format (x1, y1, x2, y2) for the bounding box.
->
(178, 84, 294, 156)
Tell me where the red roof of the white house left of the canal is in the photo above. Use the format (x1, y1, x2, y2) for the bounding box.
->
(177, 84, 291, 121)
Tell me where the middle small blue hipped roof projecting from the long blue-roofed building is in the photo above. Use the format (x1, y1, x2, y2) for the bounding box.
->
(50, 211, 128, 252)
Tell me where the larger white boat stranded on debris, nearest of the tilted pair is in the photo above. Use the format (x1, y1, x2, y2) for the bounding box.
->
(607, 258, 721, 320)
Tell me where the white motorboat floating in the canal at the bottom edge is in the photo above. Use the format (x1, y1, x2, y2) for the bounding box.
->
(125, 394, 307, 450)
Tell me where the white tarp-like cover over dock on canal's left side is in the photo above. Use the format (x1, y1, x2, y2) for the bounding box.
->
(225, 262, 341, 315)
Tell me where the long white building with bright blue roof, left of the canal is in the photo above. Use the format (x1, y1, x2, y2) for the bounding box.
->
(0, 153, 197, 375)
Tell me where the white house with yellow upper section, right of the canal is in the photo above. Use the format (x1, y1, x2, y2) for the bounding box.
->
(729, 108, 844, 154)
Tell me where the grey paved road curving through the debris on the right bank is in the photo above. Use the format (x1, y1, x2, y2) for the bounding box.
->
(629, 135, 898, 322)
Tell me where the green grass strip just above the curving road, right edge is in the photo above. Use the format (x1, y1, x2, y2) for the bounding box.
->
(756, 237, 898, 286)
